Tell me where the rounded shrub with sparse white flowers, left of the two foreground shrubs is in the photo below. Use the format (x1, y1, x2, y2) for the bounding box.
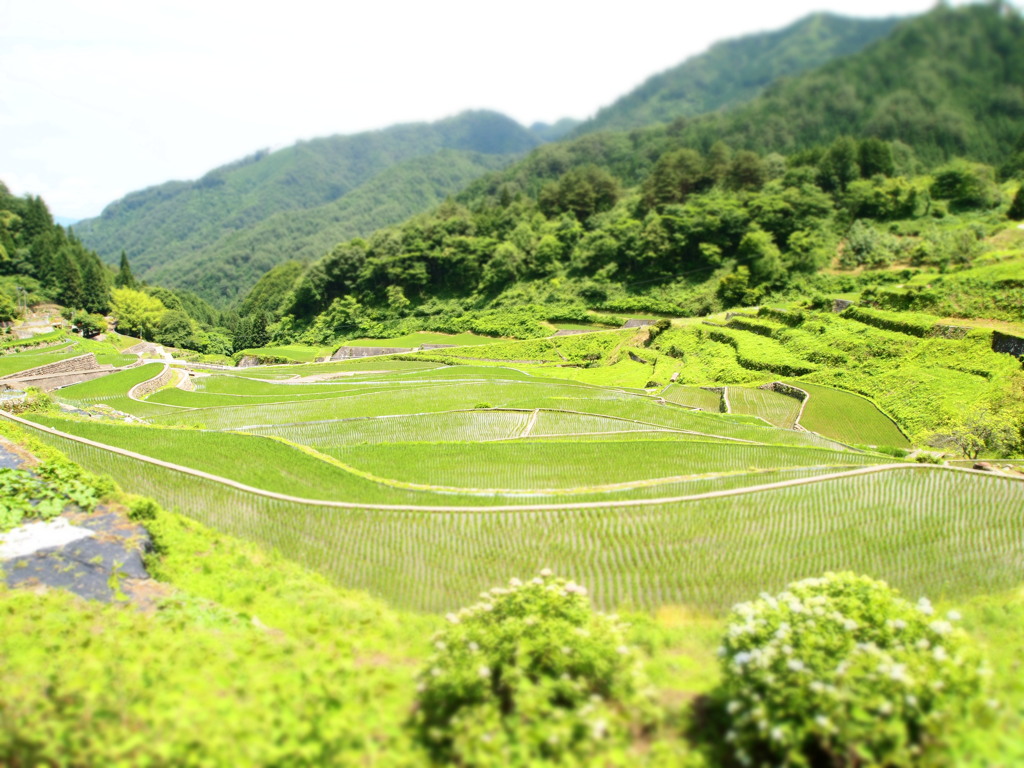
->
(414, 570, 654, 765)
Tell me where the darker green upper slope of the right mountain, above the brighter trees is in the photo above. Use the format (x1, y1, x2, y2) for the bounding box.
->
(463, 5, 1024, 201)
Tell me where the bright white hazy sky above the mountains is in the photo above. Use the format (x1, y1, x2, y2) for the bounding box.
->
(6, 0, 950, 218)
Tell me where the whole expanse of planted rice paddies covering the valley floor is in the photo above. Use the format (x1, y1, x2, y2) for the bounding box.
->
(4, 352, 1024, 612)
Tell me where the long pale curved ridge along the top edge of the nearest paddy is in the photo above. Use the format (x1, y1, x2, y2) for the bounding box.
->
(0, 412, 1024, 513)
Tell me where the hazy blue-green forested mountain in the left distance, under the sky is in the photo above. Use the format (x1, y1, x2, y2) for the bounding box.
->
(76, 112, 539, 304)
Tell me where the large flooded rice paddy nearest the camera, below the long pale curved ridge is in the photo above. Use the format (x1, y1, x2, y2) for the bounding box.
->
(4, 409, 1024, 614)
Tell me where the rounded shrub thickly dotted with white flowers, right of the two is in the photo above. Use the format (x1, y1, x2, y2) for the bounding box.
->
(721, 573, 983, 766)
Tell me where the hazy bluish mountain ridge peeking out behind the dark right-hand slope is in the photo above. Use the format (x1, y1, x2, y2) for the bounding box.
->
(572, 13, 898, 136)
